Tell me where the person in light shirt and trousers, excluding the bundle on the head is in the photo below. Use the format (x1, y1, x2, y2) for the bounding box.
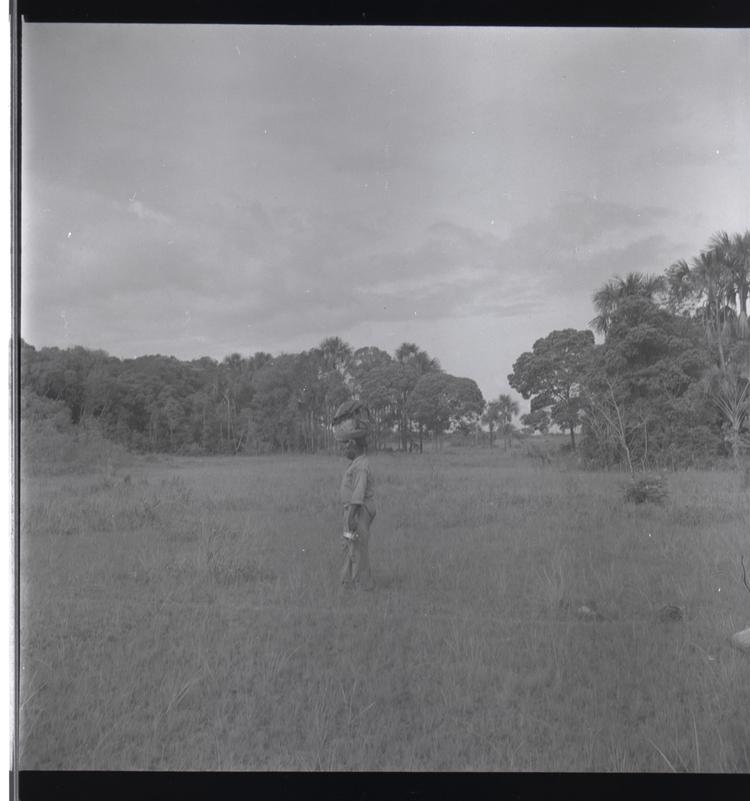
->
(341, 439, 375, 590)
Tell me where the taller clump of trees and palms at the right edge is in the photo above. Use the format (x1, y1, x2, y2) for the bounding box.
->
(508, 231, 750, 471)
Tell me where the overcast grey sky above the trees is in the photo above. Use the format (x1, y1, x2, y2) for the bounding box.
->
(20, 23, 750, 400)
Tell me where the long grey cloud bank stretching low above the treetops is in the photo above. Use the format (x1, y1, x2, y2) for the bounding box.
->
(25, 173, 692, 362)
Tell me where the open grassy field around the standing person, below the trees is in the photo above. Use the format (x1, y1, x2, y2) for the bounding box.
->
(20, 448, 750, 772)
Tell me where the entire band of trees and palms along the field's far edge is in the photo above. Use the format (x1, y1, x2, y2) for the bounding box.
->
(21, 231, 750, 470)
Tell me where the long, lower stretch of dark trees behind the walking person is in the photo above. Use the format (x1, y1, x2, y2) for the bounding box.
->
(21, 337, 485, 454)
